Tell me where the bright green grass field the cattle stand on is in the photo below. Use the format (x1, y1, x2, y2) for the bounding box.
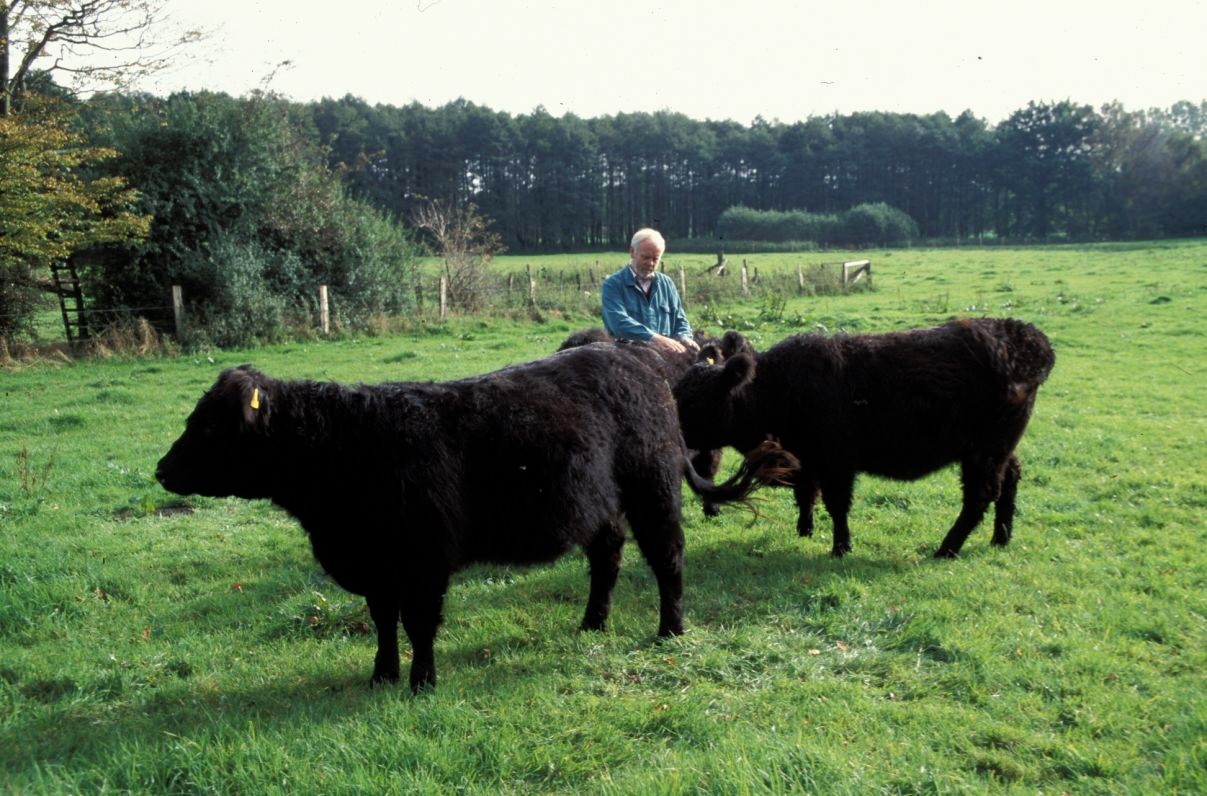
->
(0, 242, 1207, 794)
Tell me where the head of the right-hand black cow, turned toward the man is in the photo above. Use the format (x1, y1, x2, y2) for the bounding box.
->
(674, 350, 754, 451)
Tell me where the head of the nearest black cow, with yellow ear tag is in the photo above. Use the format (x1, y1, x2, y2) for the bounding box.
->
(156, 365, 276, 498)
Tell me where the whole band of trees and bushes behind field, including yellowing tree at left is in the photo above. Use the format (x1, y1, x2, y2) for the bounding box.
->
(0, 77, 1207, 344)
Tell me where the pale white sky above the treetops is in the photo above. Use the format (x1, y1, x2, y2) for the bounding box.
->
(136, 0, 1207, 123)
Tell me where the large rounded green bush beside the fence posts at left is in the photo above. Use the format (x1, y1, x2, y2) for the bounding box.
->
(80, 93, 415, 345)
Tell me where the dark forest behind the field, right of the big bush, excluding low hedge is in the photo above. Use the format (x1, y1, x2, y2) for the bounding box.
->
(305, 97, 1207, 251)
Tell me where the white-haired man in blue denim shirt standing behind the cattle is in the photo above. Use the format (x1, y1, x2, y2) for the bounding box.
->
(600, 227, 700, 353)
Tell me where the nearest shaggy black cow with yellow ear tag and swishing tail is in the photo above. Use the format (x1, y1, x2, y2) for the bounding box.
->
(156, 345, 794, 691)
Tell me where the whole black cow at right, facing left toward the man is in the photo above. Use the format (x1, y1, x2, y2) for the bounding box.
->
(675, 318, 1055, 557)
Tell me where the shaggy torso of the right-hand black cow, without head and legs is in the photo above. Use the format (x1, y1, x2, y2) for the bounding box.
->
(746, 319, 1051, 478)
